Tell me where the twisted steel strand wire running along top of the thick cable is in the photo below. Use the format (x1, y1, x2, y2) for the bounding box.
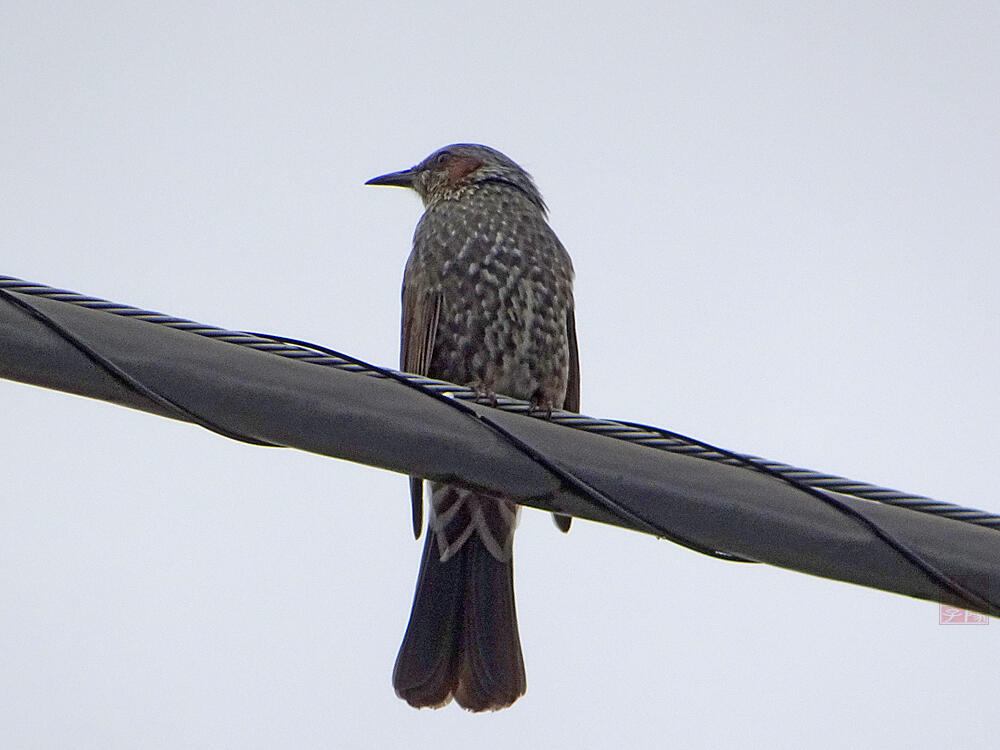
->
(0, 276, 1000, 530)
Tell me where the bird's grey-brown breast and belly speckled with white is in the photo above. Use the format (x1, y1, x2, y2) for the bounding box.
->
(408, 183, 573, 406)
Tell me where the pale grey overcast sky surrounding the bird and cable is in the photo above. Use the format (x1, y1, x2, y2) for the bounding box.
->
(0, 0, 1000, 750)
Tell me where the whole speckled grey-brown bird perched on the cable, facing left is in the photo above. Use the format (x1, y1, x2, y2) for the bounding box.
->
(366, 143, 580, 712)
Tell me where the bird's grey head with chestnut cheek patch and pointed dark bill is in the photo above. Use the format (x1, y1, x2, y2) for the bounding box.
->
(365, 143, 545, 212)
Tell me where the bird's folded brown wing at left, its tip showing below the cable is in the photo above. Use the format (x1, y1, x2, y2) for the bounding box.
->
(399, 281, 441, 539)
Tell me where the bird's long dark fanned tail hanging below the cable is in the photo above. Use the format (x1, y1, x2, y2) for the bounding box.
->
(392, 484, 526, 711)
